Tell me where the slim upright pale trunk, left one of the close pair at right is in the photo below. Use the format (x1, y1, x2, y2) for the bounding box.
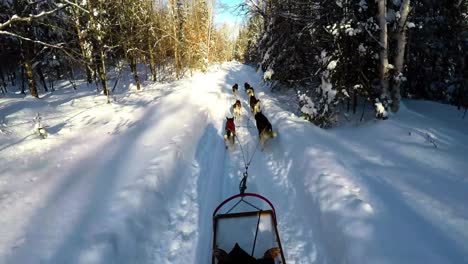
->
(378, 0, 389, 101)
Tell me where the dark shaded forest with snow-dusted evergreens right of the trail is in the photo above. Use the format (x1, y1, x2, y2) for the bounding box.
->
(236, 0, 468, 127)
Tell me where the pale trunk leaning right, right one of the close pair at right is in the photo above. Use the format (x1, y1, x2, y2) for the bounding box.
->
(391, 0, 410, 112)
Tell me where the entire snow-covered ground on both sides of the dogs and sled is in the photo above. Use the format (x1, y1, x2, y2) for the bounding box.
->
(0, 63, 468, 264)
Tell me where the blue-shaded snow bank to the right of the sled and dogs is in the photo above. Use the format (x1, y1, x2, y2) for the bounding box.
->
(229, 65, 468, 263)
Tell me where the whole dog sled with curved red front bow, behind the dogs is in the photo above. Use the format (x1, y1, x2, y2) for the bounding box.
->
(212, 192, 286, 264)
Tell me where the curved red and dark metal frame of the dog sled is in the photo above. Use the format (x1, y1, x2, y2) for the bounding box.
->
(211, 193, 286, 264)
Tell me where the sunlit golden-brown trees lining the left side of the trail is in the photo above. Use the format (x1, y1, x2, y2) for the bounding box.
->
(0, 0, 232, 102)
